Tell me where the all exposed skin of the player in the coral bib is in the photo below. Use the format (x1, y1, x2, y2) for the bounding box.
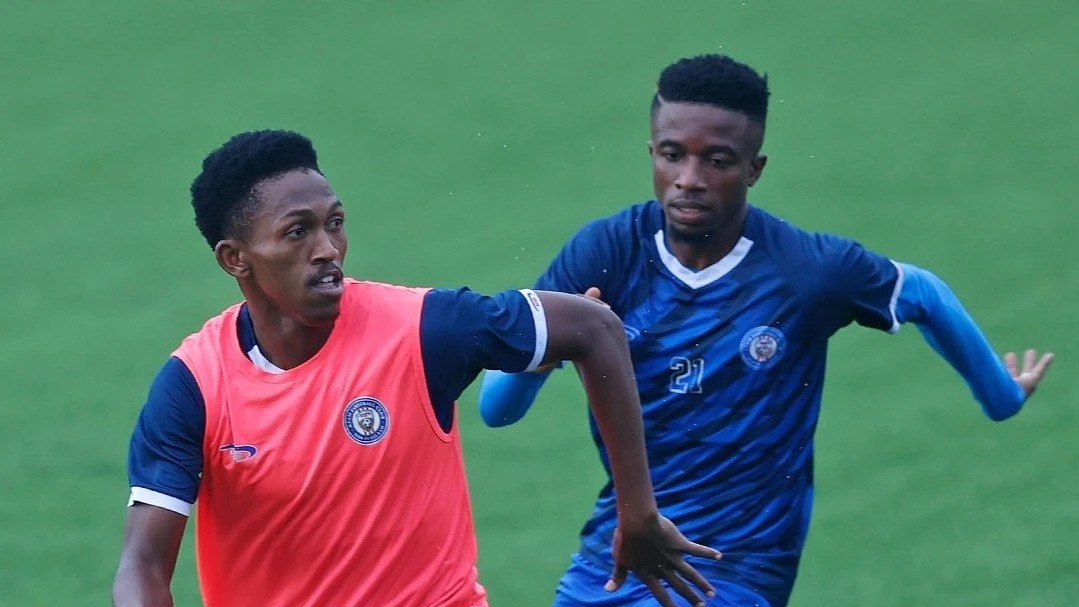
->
(112, 170, 720, 607)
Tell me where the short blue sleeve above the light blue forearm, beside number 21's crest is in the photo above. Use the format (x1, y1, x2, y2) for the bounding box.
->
(817, 234, 902, 333)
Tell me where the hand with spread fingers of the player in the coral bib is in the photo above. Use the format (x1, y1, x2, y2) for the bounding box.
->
(603, 516, 723, 607)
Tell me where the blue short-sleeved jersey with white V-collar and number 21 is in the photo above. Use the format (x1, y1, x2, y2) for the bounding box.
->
(536, 202, 901, 604)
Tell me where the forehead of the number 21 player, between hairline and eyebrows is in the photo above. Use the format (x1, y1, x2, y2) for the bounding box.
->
(652, 102, 761, 149)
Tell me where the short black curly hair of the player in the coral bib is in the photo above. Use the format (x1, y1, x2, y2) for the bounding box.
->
(191, 130, 322, 248)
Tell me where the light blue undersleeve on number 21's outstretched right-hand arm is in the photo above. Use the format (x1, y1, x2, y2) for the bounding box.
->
(896, 263, 1026, 422)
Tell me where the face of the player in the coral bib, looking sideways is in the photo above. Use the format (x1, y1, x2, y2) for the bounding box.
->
(228, 170, 349, 327)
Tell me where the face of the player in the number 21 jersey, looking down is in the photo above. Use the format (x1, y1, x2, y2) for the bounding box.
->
(648, 102, 767, 237)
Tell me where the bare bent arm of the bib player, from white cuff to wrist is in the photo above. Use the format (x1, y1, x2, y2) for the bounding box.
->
(536, 291, 658, 524)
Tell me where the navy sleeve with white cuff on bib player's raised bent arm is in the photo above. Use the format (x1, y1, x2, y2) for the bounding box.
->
(420, 289, 547, 431)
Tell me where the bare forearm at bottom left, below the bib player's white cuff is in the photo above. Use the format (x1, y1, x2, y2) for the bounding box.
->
(112, 503, 188, 607)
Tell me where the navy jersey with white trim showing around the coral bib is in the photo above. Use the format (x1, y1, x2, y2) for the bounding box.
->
(127, 289, 547, 515)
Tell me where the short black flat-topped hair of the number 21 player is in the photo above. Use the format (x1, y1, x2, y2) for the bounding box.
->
(652, 54, 769, 126)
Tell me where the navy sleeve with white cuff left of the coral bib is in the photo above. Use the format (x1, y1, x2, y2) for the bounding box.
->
(127, 357, 206, 515)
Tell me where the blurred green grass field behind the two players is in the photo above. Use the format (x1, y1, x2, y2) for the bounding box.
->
(0, 0, 1079, 607)
